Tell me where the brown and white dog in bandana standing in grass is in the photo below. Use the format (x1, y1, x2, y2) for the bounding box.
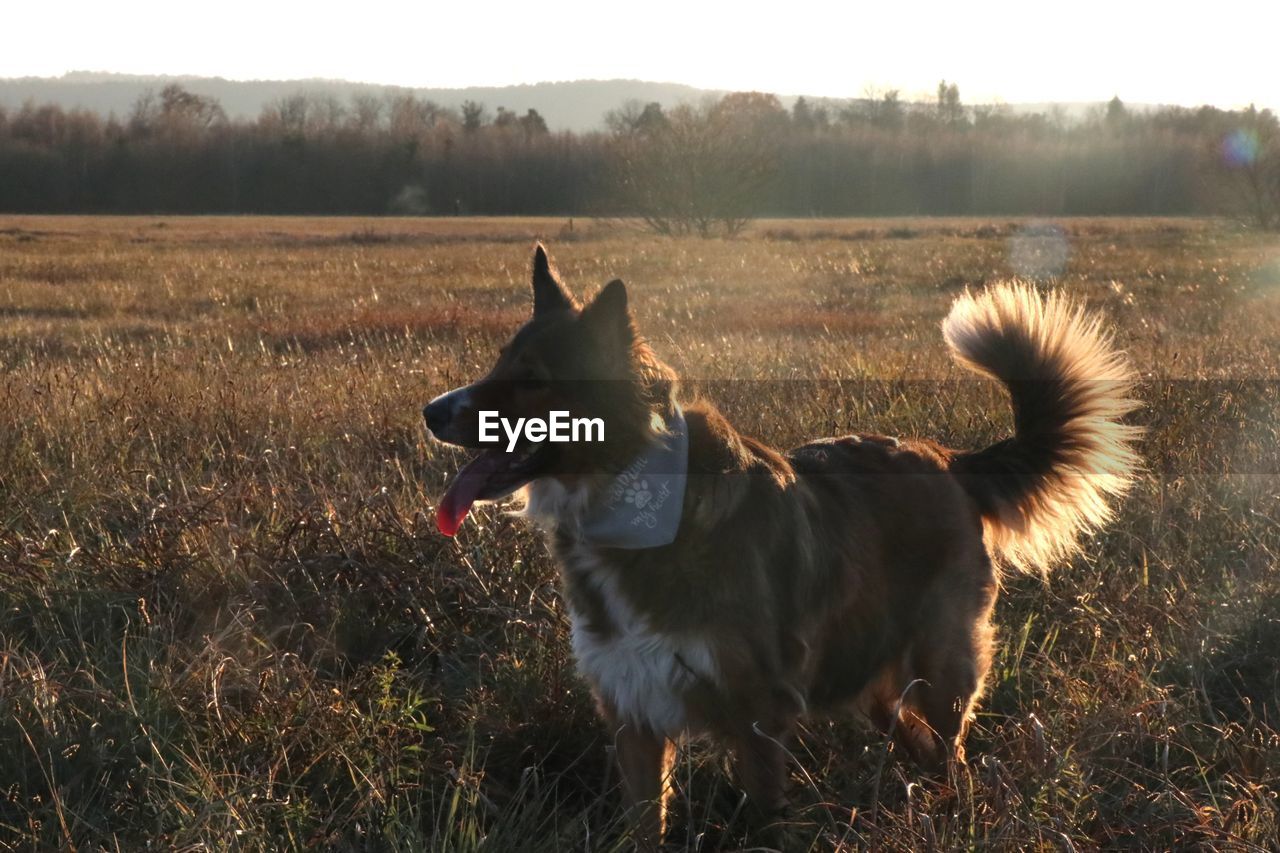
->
(424, 243, 1139, 847)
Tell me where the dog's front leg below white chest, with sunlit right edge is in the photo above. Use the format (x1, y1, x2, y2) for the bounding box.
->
(613, 722, 676, 850)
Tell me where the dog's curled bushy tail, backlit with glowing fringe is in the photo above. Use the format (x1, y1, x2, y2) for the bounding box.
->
(942, 283, 1139, 573)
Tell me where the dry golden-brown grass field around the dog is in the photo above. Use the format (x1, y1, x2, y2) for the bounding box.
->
(0, 218, 1280, 850)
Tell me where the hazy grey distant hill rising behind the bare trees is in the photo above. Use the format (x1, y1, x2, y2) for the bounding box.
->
(0, 72, 1149, 132)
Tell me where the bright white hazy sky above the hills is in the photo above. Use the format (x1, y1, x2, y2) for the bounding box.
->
(10, 0, 1280, 106)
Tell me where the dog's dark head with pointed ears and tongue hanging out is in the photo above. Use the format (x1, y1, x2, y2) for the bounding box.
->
(422, 245, 675, 535)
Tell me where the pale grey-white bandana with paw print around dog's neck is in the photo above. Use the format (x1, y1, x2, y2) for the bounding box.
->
(581, 405, 689, 548)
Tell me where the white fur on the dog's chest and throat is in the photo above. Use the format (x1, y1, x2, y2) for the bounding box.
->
(529, 487, 719, 736)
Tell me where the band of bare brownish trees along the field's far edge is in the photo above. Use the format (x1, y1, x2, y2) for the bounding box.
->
(0, 82, 1280, 234)
